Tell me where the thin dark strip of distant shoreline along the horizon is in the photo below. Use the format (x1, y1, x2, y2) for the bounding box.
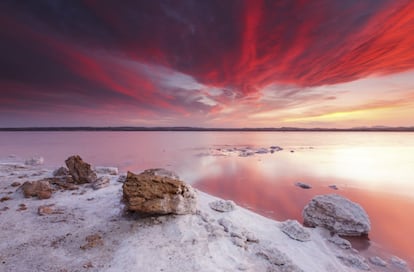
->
(0, 127, 414, 132)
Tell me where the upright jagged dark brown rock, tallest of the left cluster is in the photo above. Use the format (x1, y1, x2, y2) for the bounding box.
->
(65, 155, 98, 184)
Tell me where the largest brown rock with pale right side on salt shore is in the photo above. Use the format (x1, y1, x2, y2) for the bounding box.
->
(122, 170, 197, 214)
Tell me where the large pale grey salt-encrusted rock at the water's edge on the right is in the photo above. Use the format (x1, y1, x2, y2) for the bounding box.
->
(302, 194, 371, 236)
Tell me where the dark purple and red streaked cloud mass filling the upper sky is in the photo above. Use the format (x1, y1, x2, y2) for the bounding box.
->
(0, 0, 414, 125)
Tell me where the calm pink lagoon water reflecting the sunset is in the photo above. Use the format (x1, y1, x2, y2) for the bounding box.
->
(0, 132, 414, 267)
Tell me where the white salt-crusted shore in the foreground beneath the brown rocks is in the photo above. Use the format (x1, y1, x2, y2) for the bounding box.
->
(0, 160, 409, 272)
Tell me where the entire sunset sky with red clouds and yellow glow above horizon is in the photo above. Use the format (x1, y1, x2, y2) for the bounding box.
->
(0, 0, 414, 128)
